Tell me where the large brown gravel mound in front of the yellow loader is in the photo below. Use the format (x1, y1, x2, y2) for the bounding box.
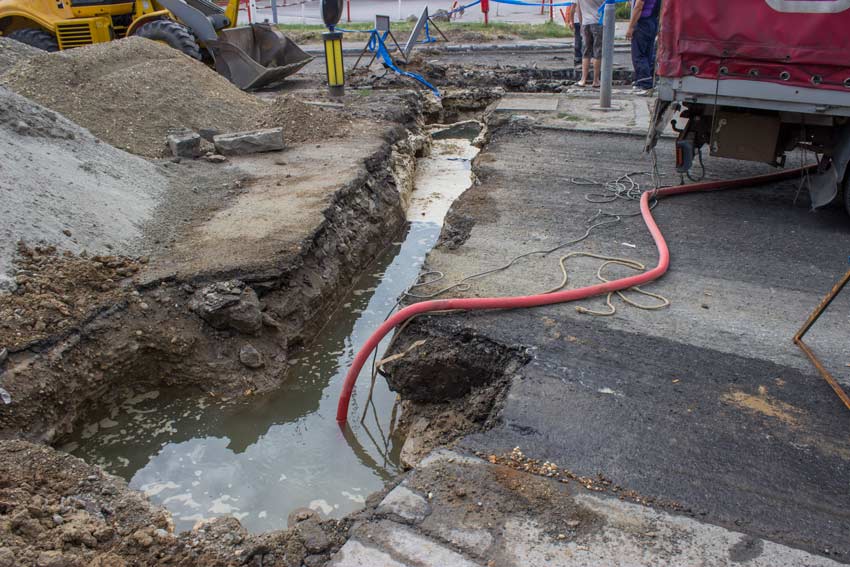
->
(0, 37, 266, 157)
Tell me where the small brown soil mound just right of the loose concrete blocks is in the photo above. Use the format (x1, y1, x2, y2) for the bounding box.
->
(263, 95, 354, 144)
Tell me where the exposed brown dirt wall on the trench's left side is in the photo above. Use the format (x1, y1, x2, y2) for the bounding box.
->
(0, 101, 427, 443)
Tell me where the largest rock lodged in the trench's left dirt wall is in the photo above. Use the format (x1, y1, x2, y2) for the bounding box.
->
(189, 280, 263, 335)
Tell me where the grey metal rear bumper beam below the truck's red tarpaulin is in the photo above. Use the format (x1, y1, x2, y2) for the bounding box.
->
(656, 77, 850, 117)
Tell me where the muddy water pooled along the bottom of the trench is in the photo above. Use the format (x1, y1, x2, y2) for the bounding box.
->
(64, 122, 477, 532)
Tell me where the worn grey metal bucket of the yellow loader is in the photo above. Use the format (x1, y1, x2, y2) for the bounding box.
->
(205, 24, 313, 90)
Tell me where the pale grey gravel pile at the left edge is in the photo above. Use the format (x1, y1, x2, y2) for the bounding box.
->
(0, 86, 168, 290)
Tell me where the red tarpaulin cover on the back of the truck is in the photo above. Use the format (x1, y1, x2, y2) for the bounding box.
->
(658, 0, 850, 91)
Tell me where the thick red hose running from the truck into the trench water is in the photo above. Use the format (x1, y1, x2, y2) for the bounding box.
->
(336, 168, 807, 426)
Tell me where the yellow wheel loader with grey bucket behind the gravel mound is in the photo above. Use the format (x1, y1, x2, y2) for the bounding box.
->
(0, 0, 312, 90)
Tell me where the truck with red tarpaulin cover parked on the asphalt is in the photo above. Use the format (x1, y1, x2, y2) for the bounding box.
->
(649, 0, 850, 213)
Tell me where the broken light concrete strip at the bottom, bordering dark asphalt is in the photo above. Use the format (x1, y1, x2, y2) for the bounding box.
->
(330, 454, 840, 567)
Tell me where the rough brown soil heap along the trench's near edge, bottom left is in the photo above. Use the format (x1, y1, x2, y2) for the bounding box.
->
(0, 441, 348, 567)
